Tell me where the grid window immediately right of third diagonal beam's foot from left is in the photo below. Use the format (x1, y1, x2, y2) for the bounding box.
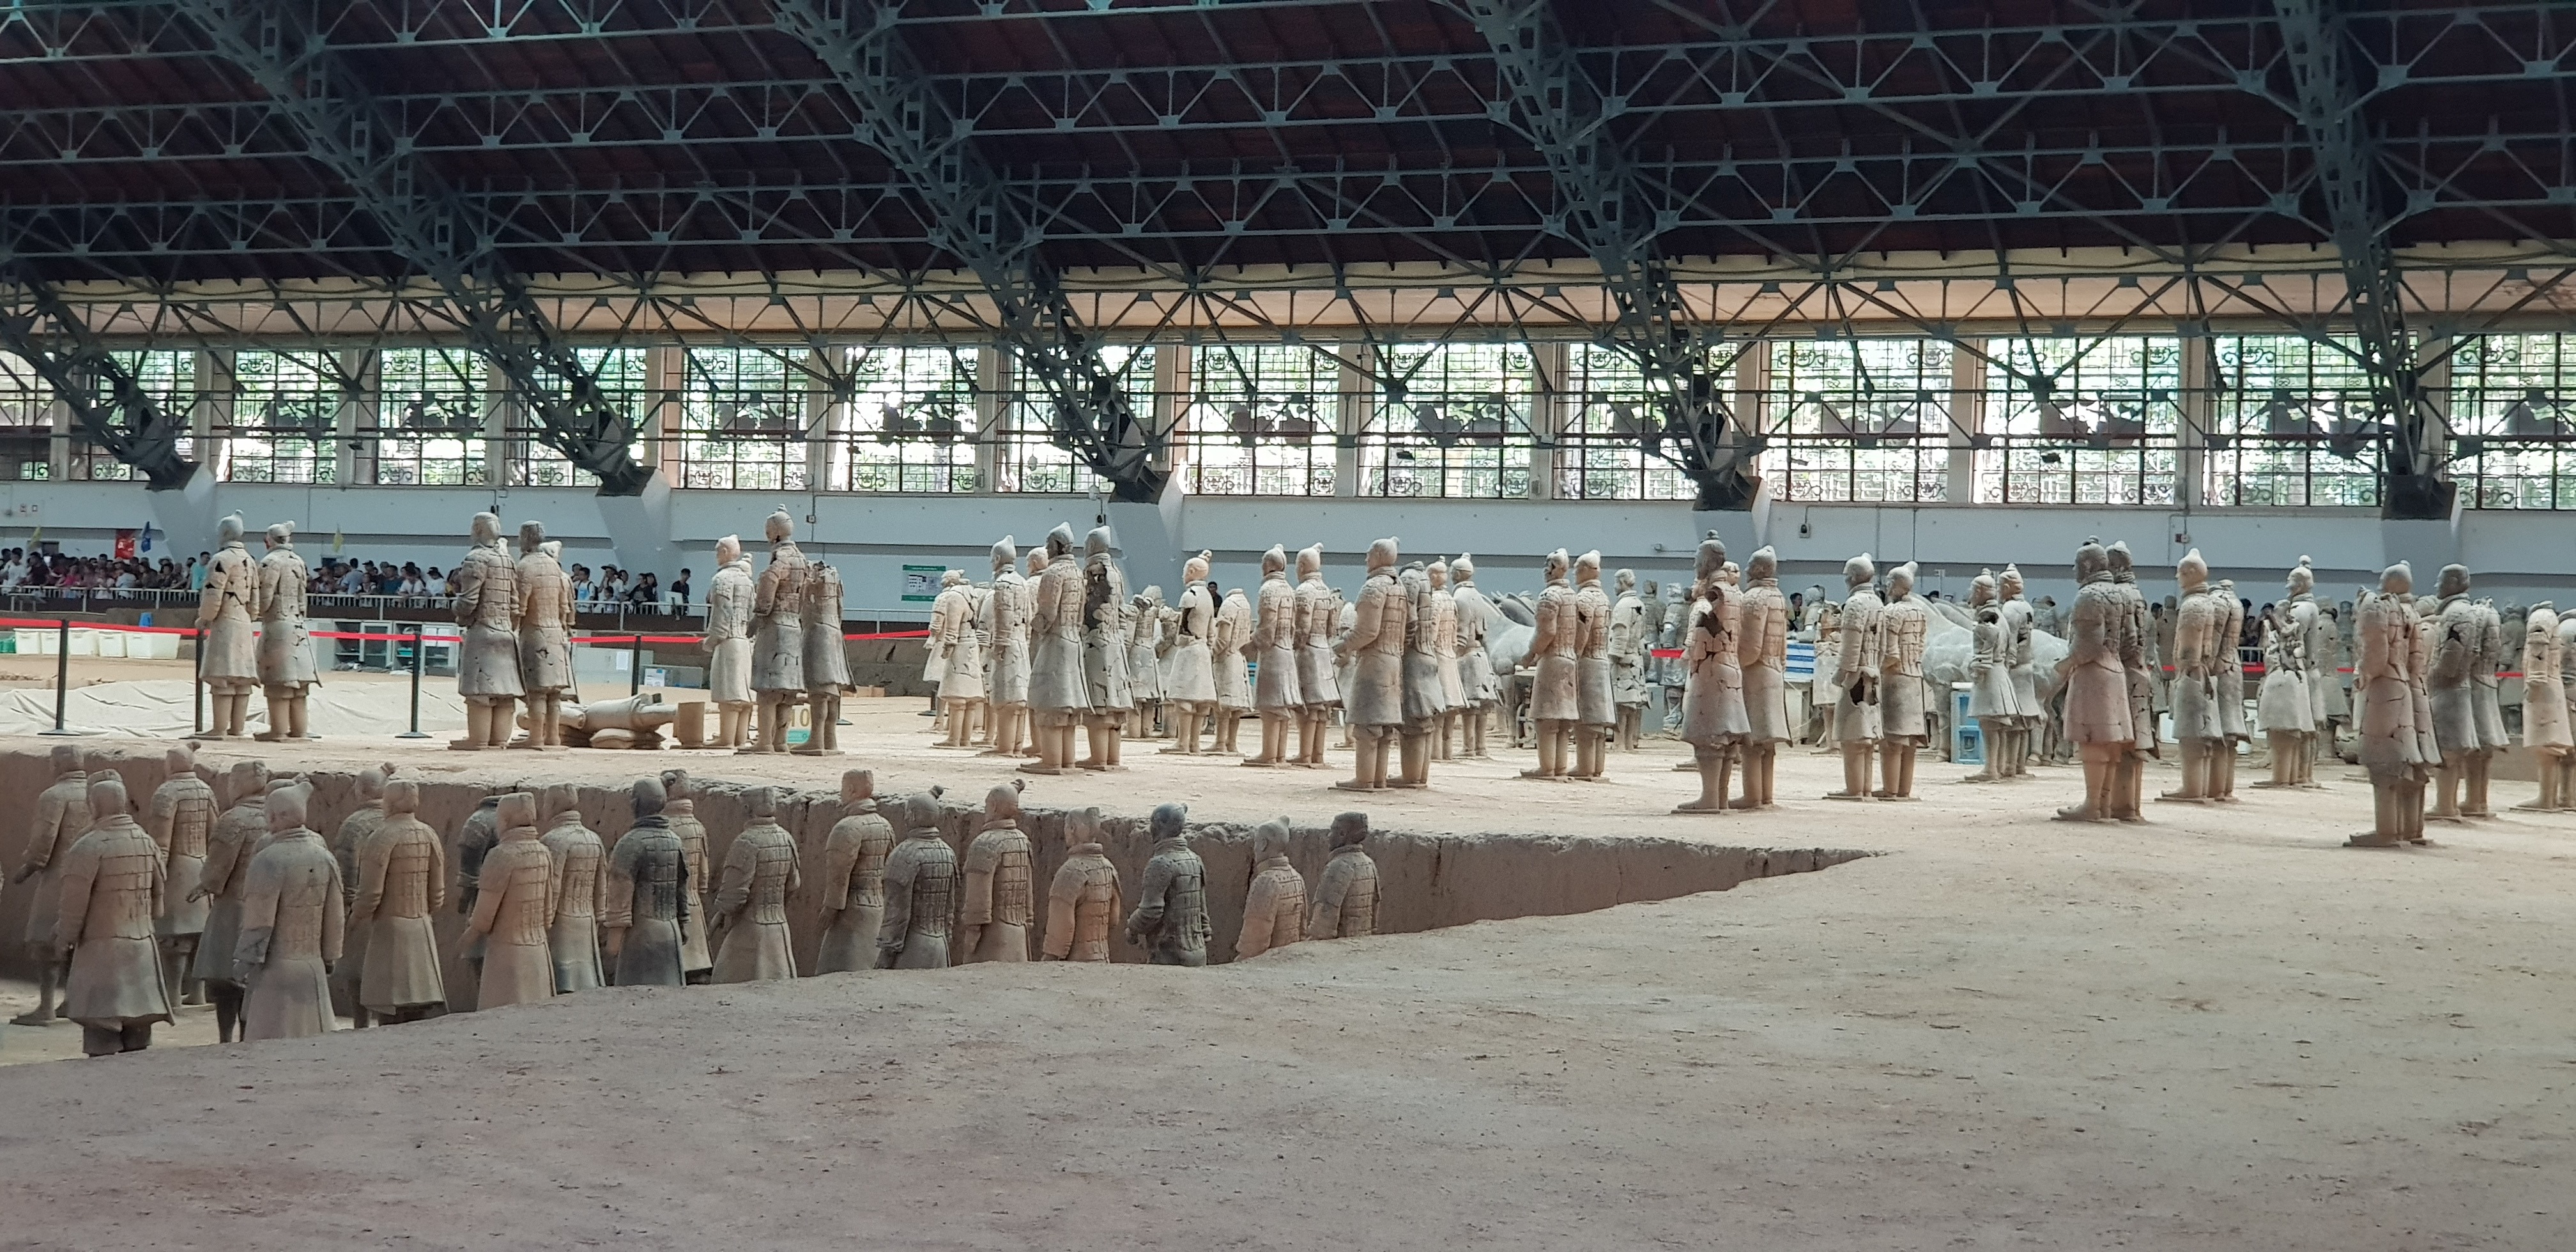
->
(1180, 342, 1342, 494)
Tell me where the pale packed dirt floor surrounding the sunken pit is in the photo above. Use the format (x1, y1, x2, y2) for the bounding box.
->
(0, 701, 2576, 1252)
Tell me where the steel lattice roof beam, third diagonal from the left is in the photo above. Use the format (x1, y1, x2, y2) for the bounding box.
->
(778, 0, 1164, 500)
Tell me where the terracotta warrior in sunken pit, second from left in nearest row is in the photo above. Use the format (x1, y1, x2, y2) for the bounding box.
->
(232, 783, 345, 1041)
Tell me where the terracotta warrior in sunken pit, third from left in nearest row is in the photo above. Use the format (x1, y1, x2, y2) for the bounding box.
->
(348, 778, 448, 1025)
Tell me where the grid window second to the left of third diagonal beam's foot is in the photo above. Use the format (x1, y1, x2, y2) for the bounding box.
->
(832, 347, 979, 492)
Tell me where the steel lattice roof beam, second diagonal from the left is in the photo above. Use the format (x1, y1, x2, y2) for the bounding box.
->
(185, 0, 652, 494)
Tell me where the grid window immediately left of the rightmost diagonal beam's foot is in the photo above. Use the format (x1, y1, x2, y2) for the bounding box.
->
(2205, 335, 2386, 507)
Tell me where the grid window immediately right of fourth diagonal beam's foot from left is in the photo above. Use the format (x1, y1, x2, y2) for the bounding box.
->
(1762, 340, 1952, 502)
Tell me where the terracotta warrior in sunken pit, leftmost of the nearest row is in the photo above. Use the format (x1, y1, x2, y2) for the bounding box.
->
(54, 770, 175, 1056)
